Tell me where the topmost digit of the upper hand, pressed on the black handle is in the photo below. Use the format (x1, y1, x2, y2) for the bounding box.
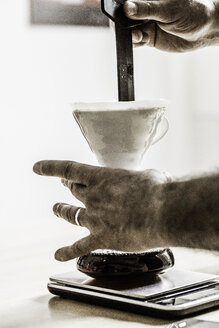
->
(124, 0, 171, 23)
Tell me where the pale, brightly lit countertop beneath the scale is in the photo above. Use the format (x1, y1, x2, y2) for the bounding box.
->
(0, 217, 219, 328)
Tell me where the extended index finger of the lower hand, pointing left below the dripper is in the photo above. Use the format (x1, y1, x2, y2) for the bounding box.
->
(33, 160, 100, 185)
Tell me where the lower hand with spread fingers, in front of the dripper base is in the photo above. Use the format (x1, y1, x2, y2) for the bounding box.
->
(34, 161, 170, 261)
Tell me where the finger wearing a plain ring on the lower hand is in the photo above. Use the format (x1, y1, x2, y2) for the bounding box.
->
(53, 203, 87, 227)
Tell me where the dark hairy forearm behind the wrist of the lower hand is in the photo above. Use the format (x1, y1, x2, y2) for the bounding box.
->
(160, 173, 219, 251)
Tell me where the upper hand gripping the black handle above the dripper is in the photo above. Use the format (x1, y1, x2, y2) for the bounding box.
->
(124, 0, 219, 52)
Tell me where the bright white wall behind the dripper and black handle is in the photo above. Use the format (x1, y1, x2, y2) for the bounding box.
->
(0, 0, 219, 226)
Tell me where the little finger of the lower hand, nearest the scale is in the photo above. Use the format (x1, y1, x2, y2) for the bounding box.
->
(55, 235, 98, 262)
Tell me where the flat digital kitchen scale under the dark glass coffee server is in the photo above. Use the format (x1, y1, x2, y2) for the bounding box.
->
(48, 269, 219, 318)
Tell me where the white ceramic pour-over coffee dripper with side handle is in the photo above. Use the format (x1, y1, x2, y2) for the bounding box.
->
(73, 100, 169, 170)
